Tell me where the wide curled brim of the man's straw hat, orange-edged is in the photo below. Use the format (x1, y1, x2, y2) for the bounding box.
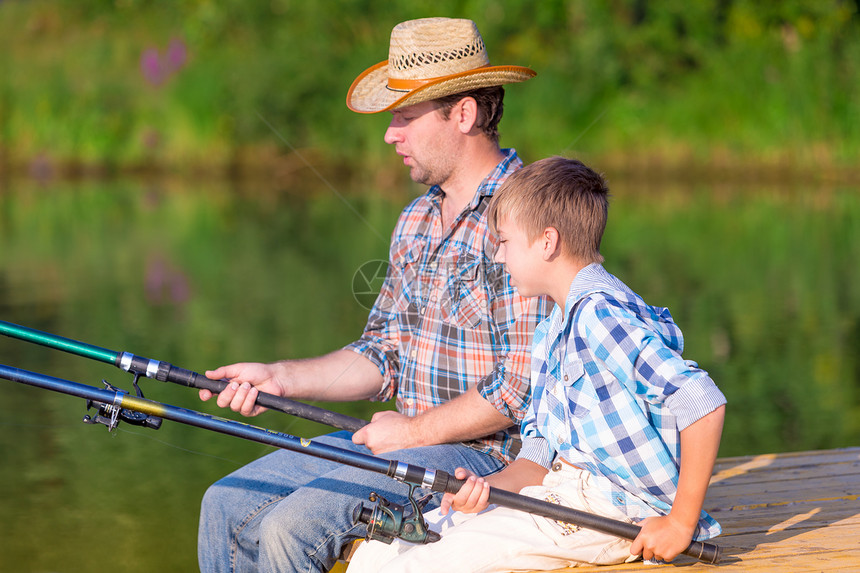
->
(346, 60, 537, 113)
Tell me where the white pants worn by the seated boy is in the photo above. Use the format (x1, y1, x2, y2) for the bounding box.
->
(348, 464, 636, 573)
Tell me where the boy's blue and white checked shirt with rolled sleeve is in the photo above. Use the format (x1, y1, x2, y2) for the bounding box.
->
(519, 264, 726, 540)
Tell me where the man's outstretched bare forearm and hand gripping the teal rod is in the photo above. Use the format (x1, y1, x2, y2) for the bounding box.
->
(200, 350, 382, 416)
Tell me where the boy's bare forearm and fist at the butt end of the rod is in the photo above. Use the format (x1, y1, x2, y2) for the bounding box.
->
(630, 406, 725, 561)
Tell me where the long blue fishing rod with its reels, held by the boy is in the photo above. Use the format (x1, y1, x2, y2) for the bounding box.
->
(0, 364, 720, 563)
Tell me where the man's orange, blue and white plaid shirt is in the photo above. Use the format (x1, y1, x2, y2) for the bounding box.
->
(346, 149, 547, 462)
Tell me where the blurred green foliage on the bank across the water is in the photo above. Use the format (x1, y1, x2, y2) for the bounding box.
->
(0, 0, 860, 174)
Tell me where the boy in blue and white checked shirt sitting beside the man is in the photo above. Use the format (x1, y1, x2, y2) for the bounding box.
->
(349, 157, 725, 573)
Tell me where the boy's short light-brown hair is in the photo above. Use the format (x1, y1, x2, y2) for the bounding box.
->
(487, 157, 609, 263)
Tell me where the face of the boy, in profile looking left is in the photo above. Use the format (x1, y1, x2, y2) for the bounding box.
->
(493, 216, 545, 296)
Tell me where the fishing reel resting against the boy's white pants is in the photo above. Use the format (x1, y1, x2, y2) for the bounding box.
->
(352, 484, 441, 543)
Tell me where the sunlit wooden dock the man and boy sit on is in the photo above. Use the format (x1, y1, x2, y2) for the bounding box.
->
(556, 447, 860, 573)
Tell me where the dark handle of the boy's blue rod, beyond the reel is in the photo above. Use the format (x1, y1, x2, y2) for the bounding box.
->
(433, 471, 720, 563)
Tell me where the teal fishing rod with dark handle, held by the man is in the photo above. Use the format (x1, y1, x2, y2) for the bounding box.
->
(0, 320, 367, 432)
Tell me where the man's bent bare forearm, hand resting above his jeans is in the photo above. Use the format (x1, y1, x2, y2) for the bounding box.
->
(352, 388, 513, 454)
